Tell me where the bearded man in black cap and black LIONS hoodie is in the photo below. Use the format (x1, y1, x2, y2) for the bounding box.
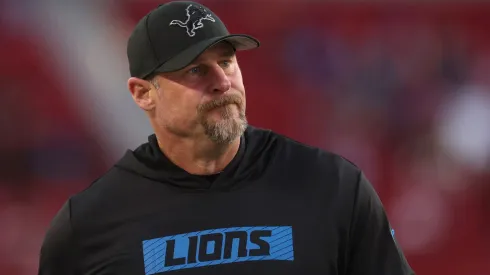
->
(39, 2, 413, 275)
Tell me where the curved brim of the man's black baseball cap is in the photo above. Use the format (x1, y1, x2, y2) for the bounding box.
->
(155, 34, 260, 73)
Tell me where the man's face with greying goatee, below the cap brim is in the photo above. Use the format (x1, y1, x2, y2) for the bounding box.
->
(154, 43, 247, 144)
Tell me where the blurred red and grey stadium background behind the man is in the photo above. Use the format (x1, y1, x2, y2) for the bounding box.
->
(0, 0, 490, 275)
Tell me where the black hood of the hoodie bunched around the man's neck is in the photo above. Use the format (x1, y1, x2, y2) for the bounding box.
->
(115, 126, 277, 190)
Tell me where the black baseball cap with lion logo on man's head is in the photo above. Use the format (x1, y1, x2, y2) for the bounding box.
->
(127, 1, 260, 79)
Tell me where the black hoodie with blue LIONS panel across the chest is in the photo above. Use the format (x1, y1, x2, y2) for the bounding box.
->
(39, 127, 414, 275)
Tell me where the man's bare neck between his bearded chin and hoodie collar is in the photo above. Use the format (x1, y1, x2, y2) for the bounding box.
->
(157, 134, 240, 175)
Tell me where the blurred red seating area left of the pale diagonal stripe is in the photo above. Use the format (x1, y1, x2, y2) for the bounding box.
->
(0, 29, 105, 275)
